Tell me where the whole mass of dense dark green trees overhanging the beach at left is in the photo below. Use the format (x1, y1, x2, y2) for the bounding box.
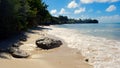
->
(0, 0, 51, 38)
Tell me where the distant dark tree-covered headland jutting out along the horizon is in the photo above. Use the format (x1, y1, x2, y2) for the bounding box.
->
(49, 16, 98, 24)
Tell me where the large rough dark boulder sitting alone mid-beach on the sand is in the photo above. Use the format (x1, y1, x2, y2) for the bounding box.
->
(36, 37, 62, 49)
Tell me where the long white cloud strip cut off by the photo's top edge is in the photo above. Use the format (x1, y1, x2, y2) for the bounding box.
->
(80, 0, 120, 4)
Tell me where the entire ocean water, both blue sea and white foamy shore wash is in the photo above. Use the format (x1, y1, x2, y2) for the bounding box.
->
(48, 23, 120, 68)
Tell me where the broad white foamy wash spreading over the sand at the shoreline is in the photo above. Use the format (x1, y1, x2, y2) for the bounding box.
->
(48, 26, 120, 68)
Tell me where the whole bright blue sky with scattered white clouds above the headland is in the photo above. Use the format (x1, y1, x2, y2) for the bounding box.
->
(43, 0, 120, 23)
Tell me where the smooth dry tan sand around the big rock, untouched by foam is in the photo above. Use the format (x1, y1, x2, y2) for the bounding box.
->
(0, 26, 93, 68)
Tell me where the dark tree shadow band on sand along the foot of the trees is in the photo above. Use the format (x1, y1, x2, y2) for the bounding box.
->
(0, 26, 52, 50)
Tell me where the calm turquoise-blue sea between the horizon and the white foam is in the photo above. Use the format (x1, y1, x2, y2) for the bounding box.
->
(56, 23, 120, 41)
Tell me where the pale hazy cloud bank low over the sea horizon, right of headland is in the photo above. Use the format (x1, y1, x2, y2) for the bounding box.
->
(98, 15, 120, 23)
